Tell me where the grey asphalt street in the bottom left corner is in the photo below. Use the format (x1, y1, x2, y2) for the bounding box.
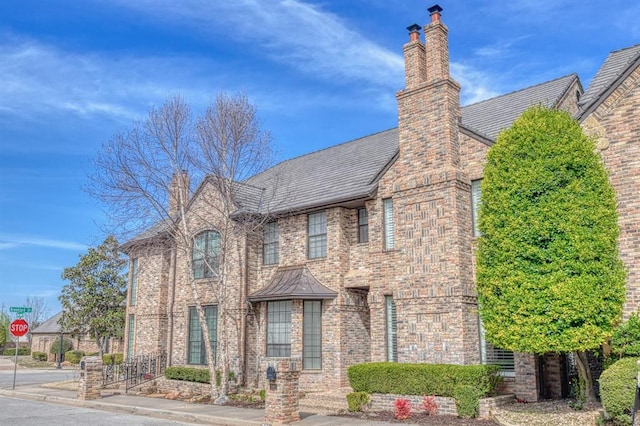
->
(0, 396, 196, 426)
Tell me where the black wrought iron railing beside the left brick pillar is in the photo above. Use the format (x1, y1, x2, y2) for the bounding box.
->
(102, 352, 167, 390)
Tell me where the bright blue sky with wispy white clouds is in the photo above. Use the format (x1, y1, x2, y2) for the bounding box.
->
(0, 0, 640, 320)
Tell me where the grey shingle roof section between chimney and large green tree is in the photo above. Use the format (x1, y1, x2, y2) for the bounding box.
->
(461, 74, 578, 141)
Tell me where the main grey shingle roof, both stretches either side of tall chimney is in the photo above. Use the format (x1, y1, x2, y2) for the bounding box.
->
(242, 74, 578, 213)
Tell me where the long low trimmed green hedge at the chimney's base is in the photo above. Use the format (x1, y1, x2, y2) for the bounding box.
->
(347, 362, 502, 397)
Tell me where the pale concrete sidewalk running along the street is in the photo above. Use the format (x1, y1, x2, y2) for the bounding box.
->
(0, 358, 404, 426)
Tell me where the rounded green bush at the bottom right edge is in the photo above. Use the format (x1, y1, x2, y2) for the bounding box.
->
(599, 357, 638, 425)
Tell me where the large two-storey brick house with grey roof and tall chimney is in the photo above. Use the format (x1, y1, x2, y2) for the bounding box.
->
(124, 5, 640, 401)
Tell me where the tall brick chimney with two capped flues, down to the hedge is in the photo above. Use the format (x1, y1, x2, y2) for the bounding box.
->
(392, 5, 480, 364)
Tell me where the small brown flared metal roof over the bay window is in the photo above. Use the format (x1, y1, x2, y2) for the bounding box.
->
(248, 267, 338, 302)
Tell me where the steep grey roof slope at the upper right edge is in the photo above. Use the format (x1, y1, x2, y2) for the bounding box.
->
(578, 44, 640, 117)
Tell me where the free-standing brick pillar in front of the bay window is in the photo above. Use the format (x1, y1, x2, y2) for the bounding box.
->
(262, 358, 302, 425)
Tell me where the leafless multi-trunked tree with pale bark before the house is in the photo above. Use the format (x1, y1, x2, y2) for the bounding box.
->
(90, 94, 272, 397)
